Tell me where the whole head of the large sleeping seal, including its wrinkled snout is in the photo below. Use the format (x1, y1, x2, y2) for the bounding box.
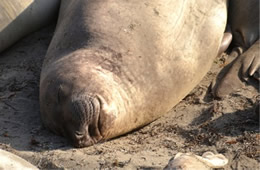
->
(40, 51, 117, 147)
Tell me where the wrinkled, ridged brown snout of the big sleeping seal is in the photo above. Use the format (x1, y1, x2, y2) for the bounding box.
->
(67, 93, 102, 147)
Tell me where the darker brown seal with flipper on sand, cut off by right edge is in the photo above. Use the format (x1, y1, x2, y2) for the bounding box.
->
(213, 0, 260, 98)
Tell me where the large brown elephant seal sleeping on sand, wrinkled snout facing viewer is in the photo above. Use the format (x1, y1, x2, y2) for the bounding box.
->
(40, 0, 227, 147)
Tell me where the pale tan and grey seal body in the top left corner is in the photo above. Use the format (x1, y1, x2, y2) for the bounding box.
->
(0, 0, 60, 52)
